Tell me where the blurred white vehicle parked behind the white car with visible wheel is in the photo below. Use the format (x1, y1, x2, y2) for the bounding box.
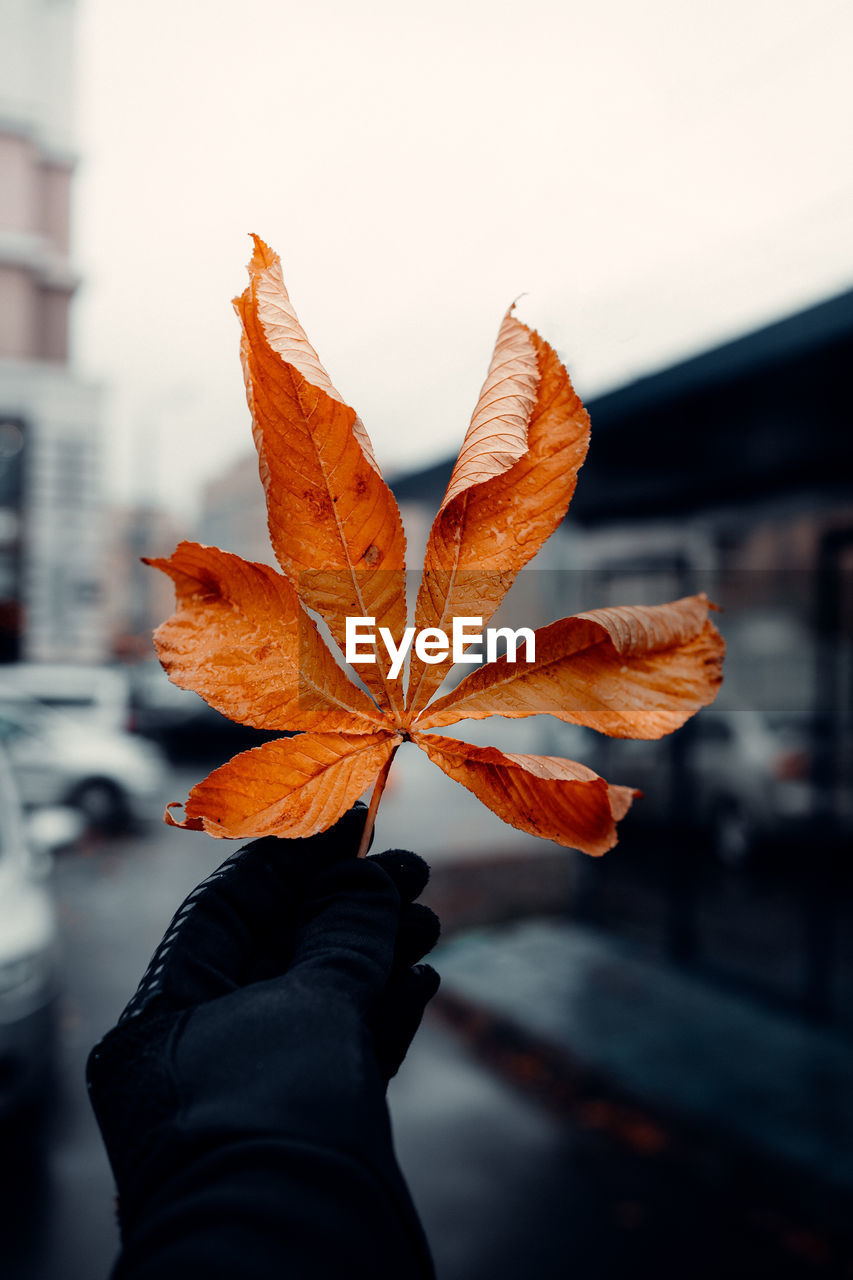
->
(0, 662, 131, 731)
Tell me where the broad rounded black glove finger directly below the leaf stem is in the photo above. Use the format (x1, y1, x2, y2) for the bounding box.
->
(288, 859, 400, 1007)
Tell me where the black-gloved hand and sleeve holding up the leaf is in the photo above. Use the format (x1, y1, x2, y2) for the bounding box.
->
(87, 806, 438, 1280)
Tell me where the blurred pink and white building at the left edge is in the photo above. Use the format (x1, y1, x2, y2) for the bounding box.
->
(0, 0, 104, 662)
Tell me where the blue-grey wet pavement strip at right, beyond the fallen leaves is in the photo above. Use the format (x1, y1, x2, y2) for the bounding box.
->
(427, 919, 853, 1194)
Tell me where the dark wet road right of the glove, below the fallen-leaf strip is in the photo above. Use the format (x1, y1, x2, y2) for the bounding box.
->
(389, 1006, 853, 1280)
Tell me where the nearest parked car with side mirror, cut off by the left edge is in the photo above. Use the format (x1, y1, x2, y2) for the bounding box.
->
(0, 750, 63, 1123)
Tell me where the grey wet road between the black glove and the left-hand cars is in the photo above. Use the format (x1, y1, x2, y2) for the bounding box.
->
(0, 783, 216, 1280)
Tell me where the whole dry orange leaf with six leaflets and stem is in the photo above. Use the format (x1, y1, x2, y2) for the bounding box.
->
(147, 238, 724, 854)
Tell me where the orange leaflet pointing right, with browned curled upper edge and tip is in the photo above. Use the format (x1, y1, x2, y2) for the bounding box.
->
(418, 595, 725, 739)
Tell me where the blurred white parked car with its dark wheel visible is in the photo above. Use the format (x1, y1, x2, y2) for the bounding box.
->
(0, 694, 164, 829)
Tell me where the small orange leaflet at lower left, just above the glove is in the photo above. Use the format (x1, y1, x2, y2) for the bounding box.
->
(164, 732, 401, 840)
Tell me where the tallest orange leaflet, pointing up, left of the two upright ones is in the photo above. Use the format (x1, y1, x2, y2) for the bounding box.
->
(234, 237, 406, 708)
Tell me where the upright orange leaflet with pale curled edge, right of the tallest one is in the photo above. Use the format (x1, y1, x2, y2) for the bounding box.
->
(407, 314, 589, 718)
